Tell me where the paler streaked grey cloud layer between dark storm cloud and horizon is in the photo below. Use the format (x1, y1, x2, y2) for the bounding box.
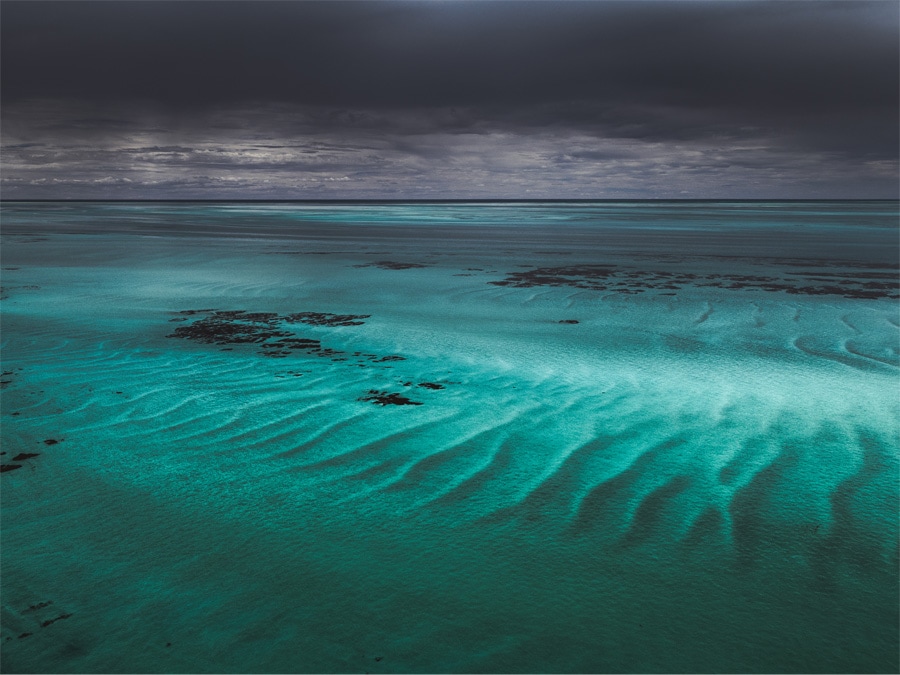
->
(2, 102, 897, 198)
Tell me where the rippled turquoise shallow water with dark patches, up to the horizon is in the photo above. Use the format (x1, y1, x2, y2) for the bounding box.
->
(0, 202, 900, 673)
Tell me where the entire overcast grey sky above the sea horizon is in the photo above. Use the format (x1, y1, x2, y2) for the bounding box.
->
(0, 0, 900, 199)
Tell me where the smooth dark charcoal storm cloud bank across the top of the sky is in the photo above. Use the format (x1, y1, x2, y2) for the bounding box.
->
(2, 0, 897, 110)
